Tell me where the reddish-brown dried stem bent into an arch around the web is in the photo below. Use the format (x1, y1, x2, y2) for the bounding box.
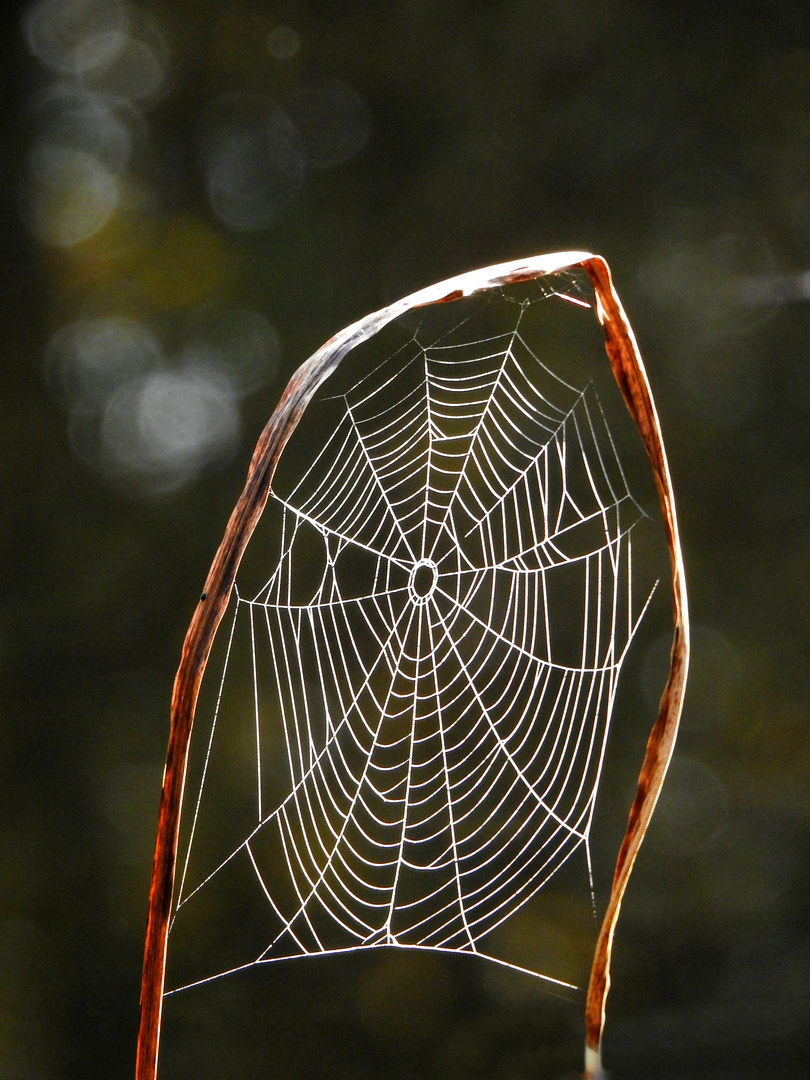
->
(135, 252, 689, 1080)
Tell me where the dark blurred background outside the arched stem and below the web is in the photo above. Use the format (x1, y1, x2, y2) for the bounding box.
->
(0, 0, 810, 1080)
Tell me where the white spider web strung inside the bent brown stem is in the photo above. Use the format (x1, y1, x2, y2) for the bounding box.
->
(170, 293, 646, 993)
